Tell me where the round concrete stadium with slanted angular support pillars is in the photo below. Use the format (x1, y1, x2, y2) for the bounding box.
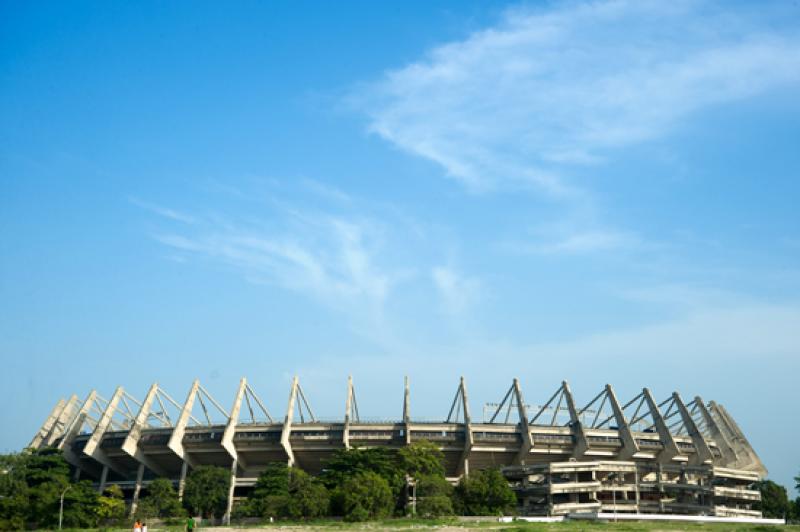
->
(30, 378, 766, 517)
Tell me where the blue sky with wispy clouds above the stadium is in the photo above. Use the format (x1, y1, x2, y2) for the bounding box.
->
(0, 1, 800, 492)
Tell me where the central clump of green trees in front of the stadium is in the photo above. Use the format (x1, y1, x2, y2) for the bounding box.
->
(235, 442, 516, 521)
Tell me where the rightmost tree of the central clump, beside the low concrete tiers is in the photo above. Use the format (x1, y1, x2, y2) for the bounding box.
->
(455, 469, 517, 515)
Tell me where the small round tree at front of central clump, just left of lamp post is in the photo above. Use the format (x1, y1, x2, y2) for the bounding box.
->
(341, 471, 395, 521)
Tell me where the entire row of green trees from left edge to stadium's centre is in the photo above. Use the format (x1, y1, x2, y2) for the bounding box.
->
(0, 442, 516, 530)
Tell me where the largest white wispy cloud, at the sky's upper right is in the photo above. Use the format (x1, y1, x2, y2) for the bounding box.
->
(353, 0, 800, 197)
